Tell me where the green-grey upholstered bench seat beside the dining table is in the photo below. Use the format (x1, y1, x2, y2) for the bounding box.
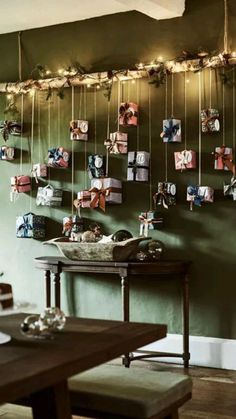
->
(0, 364, 192, 419)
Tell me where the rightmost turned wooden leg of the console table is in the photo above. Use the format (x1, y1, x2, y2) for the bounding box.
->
(183, 275, 190, 368)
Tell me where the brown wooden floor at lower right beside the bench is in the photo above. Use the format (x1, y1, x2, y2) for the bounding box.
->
(76, 360, 236, 419)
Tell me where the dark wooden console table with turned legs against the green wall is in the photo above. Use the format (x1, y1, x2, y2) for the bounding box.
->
(34, 256, 191, 368)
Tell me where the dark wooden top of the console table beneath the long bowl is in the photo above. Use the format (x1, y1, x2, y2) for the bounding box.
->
(34, 256, 191, 275)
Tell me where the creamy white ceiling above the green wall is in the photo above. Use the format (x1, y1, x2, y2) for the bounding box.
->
(0, 0, 185, 34)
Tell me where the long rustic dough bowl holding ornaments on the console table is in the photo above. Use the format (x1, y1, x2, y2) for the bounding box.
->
(44, 237, 146, 262)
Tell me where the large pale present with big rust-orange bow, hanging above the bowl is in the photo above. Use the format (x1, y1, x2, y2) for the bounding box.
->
(90, 177, 122, 211)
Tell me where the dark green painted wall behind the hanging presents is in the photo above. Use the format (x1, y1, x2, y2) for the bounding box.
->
(0, 0, 236, 338)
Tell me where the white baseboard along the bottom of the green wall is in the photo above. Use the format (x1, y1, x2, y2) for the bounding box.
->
(136, 334, 236, 370)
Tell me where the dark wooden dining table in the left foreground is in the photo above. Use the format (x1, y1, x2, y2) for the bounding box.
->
(0, 314, 167, 419)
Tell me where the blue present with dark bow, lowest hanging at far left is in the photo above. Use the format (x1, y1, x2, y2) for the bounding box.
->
(16, 212, 45, 239)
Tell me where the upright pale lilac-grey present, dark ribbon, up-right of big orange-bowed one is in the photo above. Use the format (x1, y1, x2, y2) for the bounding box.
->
(127, 151, 150, 182)
